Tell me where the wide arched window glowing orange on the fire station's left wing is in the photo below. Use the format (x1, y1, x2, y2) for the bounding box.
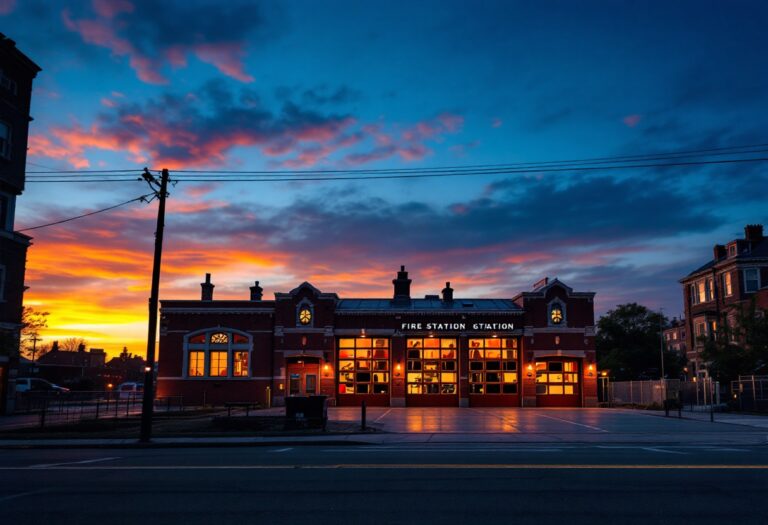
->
(184, 328, 251, 379)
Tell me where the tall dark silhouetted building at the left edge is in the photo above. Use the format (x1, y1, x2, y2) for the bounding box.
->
(0, 33, 40, 414)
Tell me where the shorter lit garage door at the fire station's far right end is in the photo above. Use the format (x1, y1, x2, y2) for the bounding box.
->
(536, 357, 581, 407)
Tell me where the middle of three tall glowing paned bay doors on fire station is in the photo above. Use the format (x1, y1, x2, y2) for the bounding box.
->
(406, 338, 458, 395)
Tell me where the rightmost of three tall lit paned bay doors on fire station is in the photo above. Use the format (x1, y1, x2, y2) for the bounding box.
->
(469, 339, 518, 394)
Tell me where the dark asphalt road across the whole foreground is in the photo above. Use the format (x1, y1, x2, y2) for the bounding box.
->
(0, 443, 768, 525)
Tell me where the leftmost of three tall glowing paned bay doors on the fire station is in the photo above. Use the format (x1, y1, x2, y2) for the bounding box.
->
(338, 337, 389, 394)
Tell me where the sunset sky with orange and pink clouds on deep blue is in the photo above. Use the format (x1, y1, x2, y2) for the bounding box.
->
(0, 0, 768, 354)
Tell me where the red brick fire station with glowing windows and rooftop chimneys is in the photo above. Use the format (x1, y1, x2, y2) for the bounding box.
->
(157, 267, 597, 407)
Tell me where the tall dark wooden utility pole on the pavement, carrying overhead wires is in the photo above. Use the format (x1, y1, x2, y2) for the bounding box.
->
(139, 168, 169, 443)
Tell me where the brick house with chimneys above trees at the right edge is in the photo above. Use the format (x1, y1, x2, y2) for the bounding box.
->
(680, 224, 768, 377)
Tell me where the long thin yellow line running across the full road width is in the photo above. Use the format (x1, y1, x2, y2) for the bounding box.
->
(0, 463, 768, 471)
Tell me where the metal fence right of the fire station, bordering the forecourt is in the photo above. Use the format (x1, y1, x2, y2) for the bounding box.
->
(607, 379, 720, 410)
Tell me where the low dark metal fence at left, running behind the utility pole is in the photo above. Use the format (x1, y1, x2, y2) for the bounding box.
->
(14, 391, 184, 427)
